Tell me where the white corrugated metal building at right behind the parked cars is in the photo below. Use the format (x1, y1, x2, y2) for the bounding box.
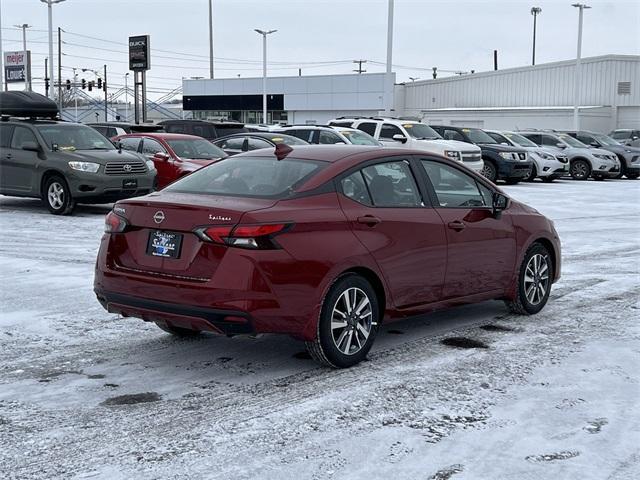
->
(395, 55, 640, 132)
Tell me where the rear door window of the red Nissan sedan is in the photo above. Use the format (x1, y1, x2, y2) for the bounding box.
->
(362, 161, 422, 207)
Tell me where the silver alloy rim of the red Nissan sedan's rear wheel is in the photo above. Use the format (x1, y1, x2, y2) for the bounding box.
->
(331, 287, 372, 355)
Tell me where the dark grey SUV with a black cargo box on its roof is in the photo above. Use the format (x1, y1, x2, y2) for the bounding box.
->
(0, 92, 156, 215)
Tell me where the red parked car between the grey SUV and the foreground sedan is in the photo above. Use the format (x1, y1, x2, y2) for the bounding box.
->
(111, 133, 227, 188)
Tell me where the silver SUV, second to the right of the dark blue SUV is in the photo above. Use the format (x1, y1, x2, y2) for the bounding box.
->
(518, 130, 620, 180)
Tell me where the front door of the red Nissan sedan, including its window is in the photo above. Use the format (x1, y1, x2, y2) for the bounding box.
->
(418, 157, 516, 299)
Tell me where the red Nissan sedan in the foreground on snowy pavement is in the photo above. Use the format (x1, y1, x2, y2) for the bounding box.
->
(94, 144, 560, 367)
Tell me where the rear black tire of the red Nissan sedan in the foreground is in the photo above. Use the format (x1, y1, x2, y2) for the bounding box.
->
(306, 274, 380, 368)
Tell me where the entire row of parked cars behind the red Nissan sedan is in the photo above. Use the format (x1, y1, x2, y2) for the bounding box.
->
(0, 92, 640, 214)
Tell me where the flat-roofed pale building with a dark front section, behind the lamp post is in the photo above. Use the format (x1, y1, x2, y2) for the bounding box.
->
(182, 73, 395, 124)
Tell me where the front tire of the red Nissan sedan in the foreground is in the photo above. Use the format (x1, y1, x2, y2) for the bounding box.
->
(505, 243, 554, 315)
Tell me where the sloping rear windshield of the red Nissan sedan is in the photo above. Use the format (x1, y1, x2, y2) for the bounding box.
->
(165, 156, 326, 198)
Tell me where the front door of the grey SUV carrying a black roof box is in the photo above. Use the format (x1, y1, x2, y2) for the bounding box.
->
(2, 125, 42, 194)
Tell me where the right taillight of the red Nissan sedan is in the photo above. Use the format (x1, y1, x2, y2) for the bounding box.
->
(195, 223, 291, 250)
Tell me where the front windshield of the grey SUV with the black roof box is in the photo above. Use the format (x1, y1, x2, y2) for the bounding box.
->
(36, 123, 116, 151)
